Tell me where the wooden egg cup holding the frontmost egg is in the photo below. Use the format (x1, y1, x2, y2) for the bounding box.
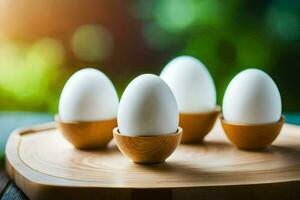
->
(113, 127, 182, 163)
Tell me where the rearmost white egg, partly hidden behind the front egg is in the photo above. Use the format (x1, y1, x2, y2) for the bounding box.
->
(160, 56, 216, 113)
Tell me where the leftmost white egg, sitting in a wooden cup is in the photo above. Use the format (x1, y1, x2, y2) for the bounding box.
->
(59, 68, 119, 122)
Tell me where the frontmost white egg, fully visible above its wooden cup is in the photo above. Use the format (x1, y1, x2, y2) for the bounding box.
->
(118, 74, 179, 136)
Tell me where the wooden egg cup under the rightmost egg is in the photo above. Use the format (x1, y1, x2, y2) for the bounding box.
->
(221, 116, 284, 150)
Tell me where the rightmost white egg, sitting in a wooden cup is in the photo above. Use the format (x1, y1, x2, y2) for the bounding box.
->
(223, 69, 281, 124)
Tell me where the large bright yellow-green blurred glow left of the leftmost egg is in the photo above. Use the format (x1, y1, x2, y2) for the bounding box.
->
(0, 38, 64, 110)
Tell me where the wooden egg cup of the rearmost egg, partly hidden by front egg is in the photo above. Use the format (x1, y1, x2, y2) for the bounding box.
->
(179, 107, 221, 143)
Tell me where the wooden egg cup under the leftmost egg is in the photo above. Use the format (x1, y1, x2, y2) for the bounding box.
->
(55, 115, 117, 149)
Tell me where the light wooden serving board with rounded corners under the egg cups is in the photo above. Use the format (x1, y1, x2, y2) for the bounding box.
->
(6, 122, 300, 199)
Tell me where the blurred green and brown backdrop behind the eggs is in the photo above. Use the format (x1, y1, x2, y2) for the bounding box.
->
(0, 0, 300, 113)
